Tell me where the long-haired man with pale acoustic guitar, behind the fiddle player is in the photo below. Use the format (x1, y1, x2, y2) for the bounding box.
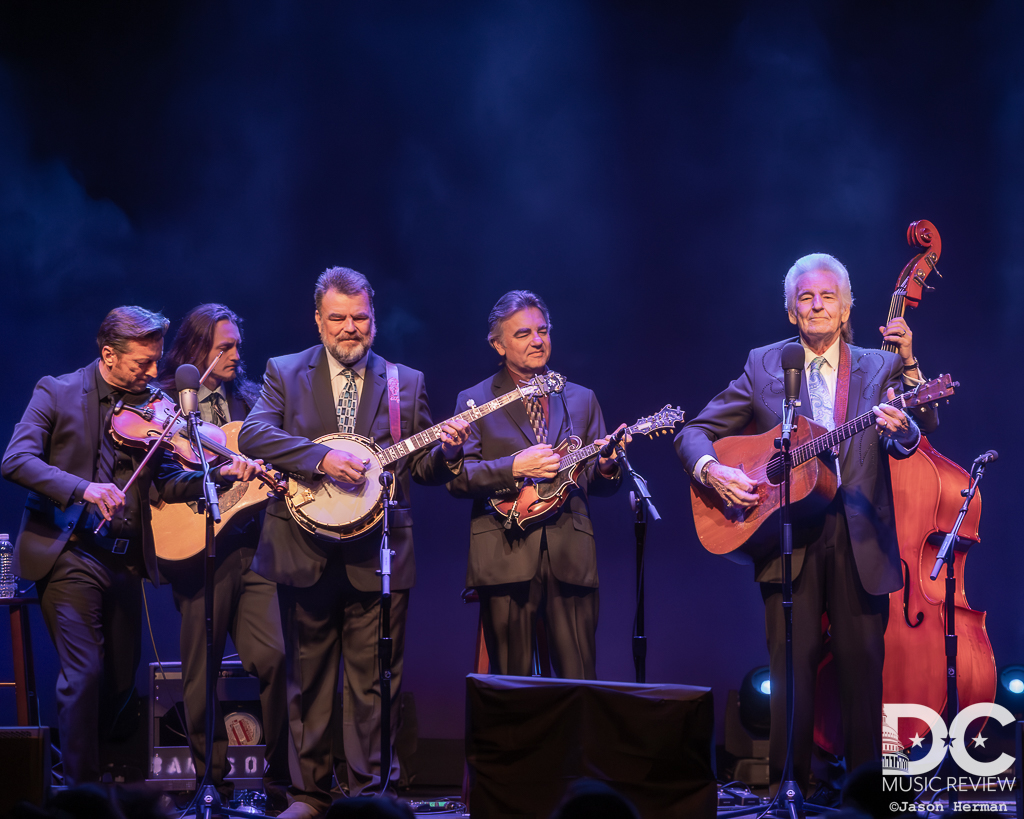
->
(160, 304, 290, 809)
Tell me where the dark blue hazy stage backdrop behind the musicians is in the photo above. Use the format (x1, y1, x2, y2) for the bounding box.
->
(0, 0, 1024, 749)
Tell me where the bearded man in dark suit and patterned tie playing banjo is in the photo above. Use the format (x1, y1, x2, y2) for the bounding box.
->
(239, 267, 469, 817)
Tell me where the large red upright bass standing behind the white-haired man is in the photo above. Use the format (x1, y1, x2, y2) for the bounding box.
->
(814, 219, 995, 756)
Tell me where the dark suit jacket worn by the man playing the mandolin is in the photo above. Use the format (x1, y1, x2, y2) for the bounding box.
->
(449, 367, 622, 588)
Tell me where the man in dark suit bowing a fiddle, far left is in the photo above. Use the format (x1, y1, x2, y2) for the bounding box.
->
(2, 307, 257, 785)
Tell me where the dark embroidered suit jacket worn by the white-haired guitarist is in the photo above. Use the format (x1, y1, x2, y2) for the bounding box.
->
(676, 339, 938, 595)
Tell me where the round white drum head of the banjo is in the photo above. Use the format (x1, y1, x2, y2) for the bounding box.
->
(285, 432, 393, 541)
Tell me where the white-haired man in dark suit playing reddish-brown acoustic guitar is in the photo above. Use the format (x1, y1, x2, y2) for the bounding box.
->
(676, 253, 938, 791)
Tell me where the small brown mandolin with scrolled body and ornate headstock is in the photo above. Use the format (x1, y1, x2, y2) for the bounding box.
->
(487, 404, 684, 529)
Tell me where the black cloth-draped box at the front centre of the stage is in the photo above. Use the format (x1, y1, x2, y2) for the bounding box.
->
(466, 674, 717, 819)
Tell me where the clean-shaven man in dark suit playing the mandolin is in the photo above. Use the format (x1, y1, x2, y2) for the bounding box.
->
(449, 290, 622, 680)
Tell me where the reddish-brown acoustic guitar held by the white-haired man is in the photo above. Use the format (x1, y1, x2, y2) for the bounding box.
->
(690, 375, 959, 563)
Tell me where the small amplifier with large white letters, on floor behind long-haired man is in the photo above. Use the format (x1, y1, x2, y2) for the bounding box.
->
(145, 660, 264, 790)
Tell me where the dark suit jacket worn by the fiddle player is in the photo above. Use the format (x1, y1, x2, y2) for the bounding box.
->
(2, 359, 209, 583)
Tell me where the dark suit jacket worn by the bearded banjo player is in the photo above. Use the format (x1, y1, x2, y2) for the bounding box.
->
(239, 345, 453, 592)
